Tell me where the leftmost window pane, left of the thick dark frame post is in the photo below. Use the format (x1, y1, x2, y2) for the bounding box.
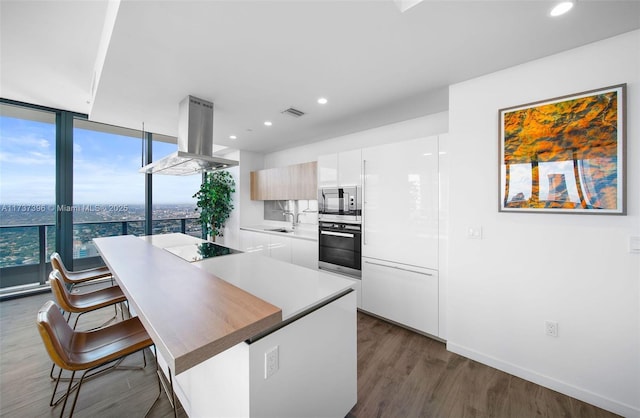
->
(0, 103, 56, 288)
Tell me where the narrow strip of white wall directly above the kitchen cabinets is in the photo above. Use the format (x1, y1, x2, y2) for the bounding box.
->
(264, 112, 448, 168)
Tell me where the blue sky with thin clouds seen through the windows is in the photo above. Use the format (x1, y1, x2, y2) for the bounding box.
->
(0, 116, 201, 205)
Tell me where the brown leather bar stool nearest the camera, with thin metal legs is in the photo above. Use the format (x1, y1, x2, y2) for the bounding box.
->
(37, 301, 162, 417)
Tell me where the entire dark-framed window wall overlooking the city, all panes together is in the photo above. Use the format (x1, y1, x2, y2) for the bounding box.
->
(0, 99, 201, 298)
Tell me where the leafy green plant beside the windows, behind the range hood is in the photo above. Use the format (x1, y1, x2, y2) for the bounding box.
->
(193, 171, 236, 239)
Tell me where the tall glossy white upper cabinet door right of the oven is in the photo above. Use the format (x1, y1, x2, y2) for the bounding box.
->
(362, 136, 439, 270)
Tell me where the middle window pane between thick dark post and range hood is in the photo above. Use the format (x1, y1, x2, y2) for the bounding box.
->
(73, 119, 145, 260)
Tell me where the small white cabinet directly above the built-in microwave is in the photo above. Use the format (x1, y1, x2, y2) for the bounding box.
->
(318, 149, 362, 188)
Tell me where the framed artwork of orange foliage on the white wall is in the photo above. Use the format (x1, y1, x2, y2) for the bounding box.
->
(499, 84, 626, 215)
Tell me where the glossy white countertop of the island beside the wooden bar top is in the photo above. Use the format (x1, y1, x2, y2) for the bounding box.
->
(193, 253, 353, 320)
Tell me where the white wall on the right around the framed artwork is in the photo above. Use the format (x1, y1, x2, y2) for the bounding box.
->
(447, 31, 640, 416)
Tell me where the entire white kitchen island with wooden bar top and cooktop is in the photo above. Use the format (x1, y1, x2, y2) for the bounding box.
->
(95, 234, 357, 417)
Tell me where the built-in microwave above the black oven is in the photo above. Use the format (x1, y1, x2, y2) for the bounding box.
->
(318, 186, 362, 223)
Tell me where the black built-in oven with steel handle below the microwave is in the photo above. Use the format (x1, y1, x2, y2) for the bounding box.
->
(318, 221, 362, 279)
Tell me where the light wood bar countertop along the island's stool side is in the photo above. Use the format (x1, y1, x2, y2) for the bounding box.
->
(94, 235, 282, 374)
